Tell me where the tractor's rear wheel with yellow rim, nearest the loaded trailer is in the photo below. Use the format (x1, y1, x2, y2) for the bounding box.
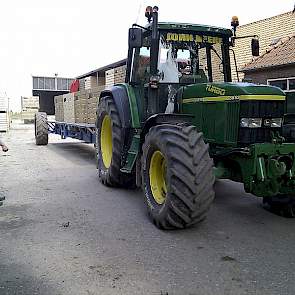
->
(96, 96, 135, 188)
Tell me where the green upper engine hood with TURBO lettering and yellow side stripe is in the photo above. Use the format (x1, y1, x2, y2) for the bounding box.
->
(182, 83, 285, 103)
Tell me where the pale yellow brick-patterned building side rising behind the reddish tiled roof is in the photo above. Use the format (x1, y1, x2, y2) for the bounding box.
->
(231, 12, 295, 80)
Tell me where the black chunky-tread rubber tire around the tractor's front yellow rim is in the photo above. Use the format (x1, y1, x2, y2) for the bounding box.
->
(142, 123, 214, 229)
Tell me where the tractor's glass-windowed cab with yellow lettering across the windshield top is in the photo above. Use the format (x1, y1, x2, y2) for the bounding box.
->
(126, 6, 232, 119)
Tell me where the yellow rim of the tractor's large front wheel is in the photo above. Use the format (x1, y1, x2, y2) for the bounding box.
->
(149, 151, 167, 205)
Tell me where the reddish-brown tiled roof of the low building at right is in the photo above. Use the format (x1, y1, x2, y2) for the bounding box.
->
(242, 33, 295, 72)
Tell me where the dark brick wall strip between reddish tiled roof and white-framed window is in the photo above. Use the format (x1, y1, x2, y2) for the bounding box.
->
(245, 65, 295, 84)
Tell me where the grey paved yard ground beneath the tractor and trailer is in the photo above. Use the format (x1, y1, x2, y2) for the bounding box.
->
(0, 125, 295, 295)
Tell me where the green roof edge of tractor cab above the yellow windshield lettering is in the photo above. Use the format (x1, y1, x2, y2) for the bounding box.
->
(158, 22, 232, 37)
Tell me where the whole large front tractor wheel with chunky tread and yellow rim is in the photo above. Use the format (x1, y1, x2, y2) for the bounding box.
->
(142, 124, 214, 229)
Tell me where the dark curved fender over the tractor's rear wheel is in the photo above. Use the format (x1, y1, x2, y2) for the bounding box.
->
(99, 86, 132, 128)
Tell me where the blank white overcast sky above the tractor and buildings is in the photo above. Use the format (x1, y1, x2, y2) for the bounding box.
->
(0, 0, 295, 110)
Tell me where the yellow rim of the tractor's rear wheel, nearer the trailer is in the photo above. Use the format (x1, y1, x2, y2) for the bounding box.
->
(100, 115, 113, 168)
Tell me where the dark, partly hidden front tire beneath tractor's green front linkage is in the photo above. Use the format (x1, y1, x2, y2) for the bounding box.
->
(263, 196, 295, 218)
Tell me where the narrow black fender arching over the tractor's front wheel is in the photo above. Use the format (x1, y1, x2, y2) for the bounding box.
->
(140, 113, 194, 146)
